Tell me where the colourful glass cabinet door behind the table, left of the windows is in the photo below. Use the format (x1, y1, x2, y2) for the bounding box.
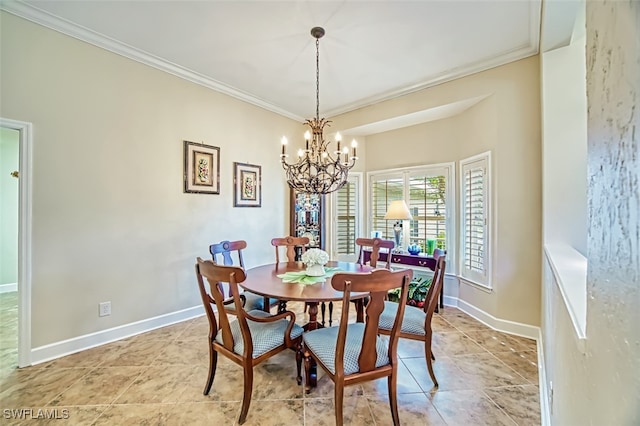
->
(291, 190, 324, 249)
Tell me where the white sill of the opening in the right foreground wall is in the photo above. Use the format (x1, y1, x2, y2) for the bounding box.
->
(544, 244, 587, 346)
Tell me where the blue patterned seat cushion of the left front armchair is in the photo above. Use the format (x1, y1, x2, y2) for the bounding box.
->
(216, 310, 304, 358)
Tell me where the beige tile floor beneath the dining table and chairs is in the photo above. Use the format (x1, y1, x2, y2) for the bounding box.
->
(0, 293, 540, 426)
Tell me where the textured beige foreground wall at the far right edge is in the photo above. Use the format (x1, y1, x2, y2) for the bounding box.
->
(542, 1, 640, 425)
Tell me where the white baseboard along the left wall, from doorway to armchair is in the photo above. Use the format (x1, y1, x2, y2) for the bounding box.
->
(31, 305, 204, 365)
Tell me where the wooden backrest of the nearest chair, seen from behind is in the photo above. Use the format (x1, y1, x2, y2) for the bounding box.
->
(331, 269, 413, 373)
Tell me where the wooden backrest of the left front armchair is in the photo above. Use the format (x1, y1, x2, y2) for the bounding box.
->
(196, 258, 253, 355)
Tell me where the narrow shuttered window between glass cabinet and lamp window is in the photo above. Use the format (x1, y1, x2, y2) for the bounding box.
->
(332, 173, 362, 261)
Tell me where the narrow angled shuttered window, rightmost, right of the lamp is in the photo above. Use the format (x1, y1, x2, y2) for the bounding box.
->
(460, 152, 491, 288)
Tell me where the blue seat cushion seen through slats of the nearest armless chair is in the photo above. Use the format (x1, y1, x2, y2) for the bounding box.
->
(302, 323, 389, 375)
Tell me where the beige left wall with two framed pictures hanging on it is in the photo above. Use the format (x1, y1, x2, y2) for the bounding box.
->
(0, 12, 301, 348)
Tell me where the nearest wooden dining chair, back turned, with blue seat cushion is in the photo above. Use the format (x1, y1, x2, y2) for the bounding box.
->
(302, 269, 413, 425)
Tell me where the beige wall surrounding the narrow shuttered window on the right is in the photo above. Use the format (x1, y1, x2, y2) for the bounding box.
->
(335, 57, 541, 326)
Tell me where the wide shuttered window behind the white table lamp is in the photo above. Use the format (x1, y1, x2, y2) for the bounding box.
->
(369, 164, 453, 253)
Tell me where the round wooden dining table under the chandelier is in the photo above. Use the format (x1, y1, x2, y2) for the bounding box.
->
(239, 262, 373, 330)
